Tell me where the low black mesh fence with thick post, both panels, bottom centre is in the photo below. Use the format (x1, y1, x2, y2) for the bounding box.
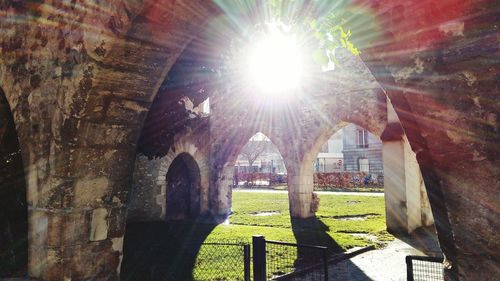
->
(185, 236, 329, 281)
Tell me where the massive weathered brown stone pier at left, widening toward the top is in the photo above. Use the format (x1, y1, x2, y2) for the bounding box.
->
(0, 1, 217, 280)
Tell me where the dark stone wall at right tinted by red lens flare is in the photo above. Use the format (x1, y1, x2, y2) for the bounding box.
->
(362, 0, 500, 280)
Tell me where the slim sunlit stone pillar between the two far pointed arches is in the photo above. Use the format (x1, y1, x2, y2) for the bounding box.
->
(287, 161, 314, 219)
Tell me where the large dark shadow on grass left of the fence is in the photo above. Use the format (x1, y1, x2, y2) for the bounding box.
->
(120, 220, 216, 281)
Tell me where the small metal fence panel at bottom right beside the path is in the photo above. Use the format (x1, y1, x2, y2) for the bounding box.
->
(406, 256, 444, 281)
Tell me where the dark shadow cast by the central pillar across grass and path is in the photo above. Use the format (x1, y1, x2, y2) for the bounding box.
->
(291, 217, 371, 281)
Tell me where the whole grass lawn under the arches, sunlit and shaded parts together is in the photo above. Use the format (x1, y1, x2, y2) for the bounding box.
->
(122, 191, 391, 280)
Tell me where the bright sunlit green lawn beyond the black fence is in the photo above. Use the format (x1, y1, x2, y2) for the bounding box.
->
(207, 191, 387, 247)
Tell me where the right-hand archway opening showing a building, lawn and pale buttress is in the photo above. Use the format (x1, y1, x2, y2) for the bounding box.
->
(313, 120, 441, 255)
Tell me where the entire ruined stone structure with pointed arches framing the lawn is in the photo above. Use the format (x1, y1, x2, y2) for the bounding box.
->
(0, 0, 500, 280)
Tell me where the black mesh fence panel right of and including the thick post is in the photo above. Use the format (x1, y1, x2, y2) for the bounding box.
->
(252, 236, 328, 281)
